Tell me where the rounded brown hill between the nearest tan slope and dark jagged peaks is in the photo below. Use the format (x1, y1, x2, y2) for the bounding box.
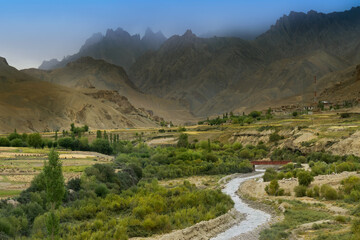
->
(22, 57, 195, 123)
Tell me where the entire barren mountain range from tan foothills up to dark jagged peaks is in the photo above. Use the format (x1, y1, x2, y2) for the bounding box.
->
(0, 7, 360, 131)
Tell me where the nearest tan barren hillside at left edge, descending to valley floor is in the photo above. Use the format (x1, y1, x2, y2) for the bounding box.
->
(0, 57, 157, 132)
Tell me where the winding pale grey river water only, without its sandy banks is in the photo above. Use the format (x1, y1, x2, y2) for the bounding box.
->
(212, 173, 271, 240)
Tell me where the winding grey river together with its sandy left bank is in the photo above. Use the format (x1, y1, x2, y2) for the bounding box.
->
(131, 172, 280, 240)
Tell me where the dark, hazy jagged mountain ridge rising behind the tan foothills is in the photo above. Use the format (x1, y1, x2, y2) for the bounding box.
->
(30, 7, 360, 120)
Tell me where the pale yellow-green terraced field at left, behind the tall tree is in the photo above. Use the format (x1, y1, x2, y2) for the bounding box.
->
(0, 147, 112, 198)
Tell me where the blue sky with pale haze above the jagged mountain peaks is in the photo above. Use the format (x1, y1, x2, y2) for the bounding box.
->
(0, 0, 360, 69)
